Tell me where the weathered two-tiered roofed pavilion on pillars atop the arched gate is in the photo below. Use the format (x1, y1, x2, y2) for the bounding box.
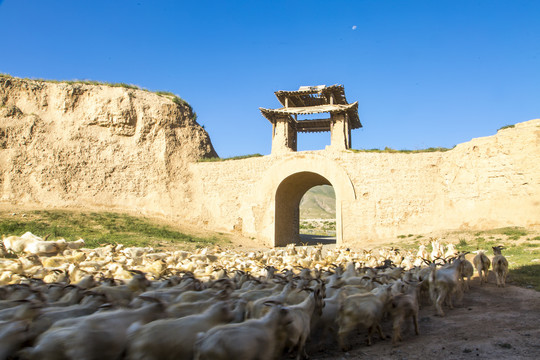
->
(259, 85, 362, 154)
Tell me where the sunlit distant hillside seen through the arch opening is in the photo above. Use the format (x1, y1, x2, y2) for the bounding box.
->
(300, 185, 336, 219)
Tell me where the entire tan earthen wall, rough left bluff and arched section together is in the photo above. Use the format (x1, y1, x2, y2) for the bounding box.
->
(0, 76, 540, 246)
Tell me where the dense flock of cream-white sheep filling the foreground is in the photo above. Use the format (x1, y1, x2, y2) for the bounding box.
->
(0, 233, 508, 360)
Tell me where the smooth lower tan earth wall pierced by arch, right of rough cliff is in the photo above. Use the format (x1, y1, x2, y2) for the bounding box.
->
(190, 120, 540, 245)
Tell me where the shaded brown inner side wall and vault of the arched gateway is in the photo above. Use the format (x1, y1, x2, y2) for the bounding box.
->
(274, 171, 339, 246)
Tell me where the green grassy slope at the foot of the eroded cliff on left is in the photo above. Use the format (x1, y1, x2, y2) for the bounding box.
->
(0, 210, 224, 248)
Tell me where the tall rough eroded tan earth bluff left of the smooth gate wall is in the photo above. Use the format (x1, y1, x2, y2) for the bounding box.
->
(0, 77, 217, 215)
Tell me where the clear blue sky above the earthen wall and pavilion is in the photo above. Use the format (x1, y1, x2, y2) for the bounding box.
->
(0, 0, 540, 157)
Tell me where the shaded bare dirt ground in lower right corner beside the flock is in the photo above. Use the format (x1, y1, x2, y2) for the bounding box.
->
(309, 274, 540, 360)
